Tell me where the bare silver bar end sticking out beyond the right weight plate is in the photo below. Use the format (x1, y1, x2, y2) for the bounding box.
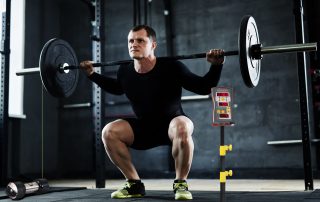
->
(261, 42, 317, 55)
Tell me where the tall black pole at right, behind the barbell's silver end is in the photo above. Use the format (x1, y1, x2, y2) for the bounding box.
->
(294, 0, 313, 190)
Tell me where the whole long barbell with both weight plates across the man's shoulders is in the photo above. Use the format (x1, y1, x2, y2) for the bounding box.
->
(16, 15, 317, 97)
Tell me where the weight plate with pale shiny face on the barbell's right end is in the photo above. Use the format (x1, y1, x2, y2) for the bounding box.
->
(238, 15, 261, 88)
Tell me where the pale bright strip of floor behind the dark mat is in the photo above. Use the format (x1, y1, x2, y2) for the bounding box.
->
(49, 179, 320, 192)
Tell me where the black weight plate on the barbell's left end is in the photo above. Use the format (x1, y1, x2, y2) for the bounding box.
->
(39, 38, 79, 97)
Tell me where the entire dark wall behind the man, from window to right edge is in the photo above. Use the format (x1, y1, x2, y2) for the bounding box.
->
(13, 0, 319, 178)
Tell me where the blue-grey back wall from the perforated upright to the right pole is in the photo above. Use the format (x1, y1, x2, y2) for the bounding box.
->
(96, 0, 316, 177)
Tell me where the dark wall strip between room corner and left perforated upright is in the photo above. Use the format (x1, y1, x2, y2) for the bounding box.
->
(59, 0, 94, 177)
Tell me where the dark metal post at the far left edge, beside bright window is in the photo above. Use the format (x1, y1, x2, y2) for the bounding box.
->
(0, 0, 11, 185)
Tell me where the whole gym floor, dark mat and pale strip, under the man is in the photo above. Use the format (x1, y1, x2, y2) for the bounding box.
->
(0, 179, 320, 202)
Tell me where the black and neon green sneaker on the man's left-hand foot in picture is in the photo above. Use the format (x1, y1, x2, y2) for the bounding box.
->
(111, 180, 146, 199)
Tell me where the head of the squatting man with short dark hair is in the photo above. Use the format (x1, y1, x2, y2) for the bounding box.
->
(128, 25, 157, 59)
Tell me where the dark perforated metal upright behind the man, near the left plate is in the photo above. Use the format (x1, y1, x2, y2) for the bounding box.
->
(92, 0, 105, 188)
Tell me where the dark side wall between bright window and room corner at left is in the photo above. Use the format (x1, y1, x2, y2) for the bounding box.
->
(17, 0, 60, 177)
